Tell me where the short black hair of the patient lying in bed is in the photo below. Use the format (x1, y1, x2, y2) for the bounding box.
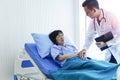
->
(49, 30, 63, 45)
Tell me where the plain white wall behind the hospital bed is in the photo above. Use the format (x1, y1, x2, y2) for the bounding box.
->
(0, 0, 77, 80)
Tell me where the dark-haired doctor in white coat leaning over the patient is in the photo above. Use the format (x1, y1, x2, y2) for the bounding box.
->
(79, 0, 120, 63)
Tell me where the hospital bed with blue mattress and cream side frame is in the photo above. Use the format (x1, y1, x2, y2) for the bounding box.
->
(14, 43, 120, 80)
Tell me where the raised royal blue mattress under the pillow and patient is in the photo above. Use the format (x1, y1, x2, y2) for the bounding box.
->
(25, 43, 60, 78)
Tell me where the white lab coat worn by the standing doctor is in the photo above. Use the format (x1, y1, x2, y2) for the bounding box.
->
(84, 10, 120, 63)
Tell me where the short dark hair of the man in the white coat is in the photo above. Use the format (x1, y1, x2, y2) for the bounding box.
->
(82, 0, 99, 10)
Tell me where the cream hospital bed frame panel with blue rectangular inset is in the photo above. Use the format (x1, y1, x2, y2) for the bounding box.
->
(14, 49, 52, 80)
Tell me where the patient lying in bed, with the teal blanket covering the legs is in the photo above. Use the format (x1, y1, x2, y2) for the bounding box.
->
(49, 30, 119, 80)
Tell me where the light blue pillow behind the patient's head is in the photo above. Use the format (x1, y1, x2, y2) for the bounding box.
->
(32, 33, 53, 58)
